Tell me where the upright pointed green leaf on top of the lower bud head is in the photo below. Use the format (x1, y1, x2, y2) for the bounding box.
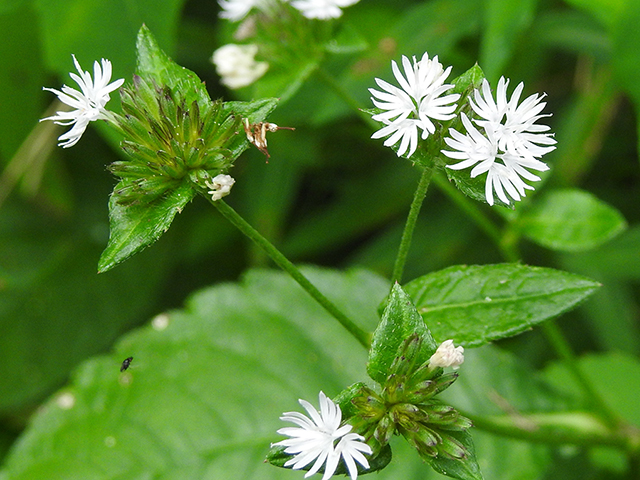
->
(367, 283, 438, 385)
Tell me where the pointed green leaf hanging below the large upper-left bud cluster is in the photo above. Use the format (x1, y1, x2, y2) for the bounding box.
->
(98, 180, 195, 272)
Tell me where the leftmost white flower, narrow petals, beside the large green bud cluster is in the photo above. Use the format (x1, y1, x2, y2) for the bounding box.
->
(40, 55, 124, 148)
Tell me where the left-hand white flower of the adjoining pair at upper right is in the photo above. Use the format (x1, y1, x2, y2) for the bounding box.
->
(369, 53, 460, 157)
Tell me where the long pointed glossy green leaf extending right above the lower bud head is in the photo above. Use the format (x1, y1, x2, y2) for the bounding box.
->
(404, 264, 599, 347)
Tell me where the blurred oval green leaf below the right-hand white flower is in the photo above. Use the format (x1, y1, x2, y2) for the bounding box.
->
(517, 189, 627, 252)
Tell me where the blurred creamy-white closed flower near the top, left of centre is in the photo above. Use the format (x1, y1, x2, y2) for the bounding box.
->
(211, 43, 269, 89)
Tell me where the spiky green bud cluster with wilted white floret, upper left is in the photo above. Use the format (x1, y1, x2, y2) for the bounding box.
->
(109, 75, 241, 204)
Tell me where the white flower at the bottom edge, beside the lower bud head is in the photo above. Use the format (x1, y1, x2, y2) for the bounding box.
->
(273, 392, 372, 480)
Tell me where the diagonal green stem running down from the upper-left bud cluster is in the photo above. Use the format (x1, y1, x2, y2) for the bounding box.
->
(209, 198, 371, 350)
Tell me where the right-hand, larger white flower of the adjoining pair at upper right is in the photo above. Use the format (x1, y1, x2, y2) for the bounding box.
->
(442, 77, 556, 205)
